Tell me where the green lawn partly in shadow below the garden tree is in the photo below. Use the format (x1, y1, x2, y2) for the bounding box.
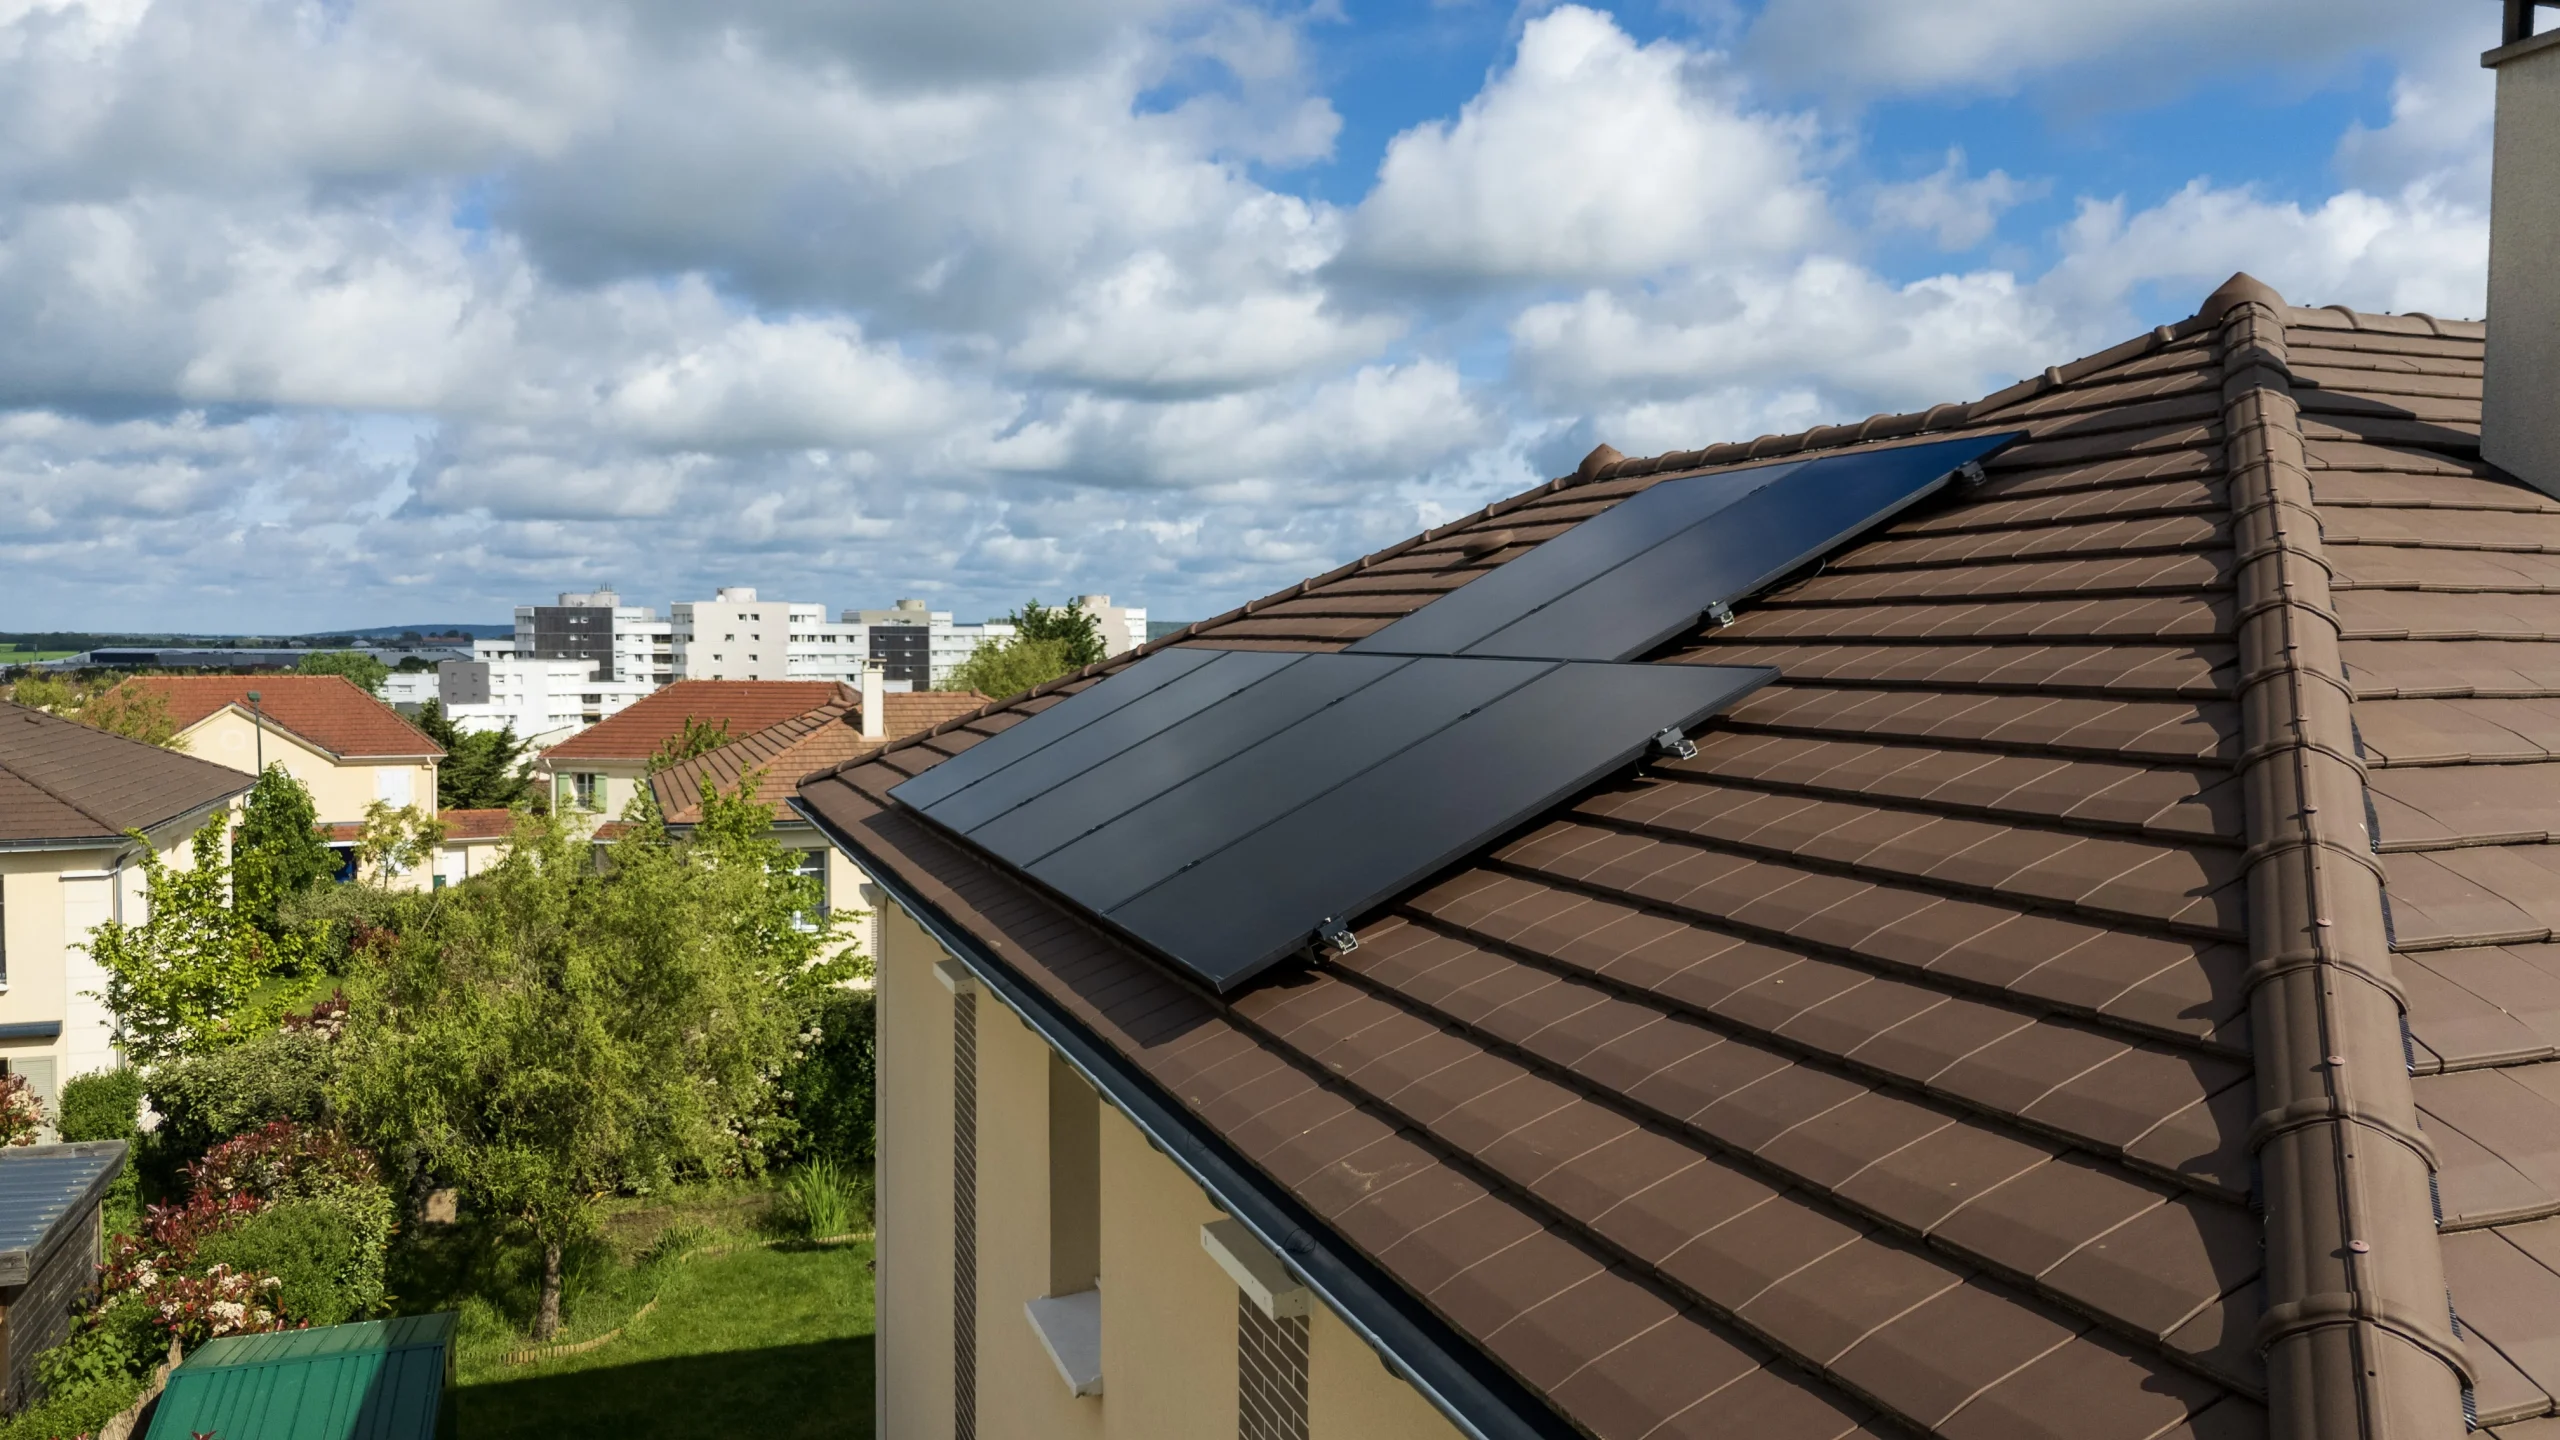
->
(394, 1186, 873, 1440)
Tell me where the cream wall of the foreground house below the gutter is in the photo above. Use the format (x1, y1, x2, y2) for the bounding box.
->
(878, 907, 1457, 1440)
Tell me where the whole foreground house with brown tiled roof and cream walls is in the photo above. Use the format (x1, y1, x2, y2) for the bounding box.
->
(799, 257, 2560, 1440)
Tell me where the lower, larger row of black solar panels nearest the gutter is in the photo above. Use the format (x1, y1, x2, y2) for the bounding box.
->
(891, 651, 1777, 989)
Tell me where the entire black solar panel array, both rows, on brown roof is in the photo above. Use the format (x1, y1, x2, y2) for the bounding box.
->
(891, 436, 2015, 989)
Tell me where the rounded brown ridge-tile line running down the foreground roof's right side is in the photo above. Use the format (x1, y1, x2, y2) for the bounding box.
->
(2209, 288, 2470, 1440)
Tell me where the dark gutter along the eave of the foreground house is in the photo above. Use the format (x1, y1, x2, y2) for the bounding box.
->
(791, 797, 1580, 1440)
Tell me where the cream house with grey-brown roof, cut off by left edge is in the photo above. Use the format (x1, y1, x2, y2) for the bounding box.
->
(0, 702, 253, 1115)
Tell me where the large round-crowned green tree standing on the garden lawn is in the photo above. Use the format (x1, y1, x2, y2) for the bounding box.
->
(335, 784, 845, 1340)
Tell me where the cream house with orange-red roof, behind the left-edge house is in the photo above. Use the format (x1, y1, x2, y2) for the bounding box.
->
(115, 674, 445, 825)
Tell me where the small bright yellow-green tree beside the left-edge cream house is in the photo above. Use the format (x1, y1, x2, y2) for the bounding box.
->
(90, 822, 276, 1066)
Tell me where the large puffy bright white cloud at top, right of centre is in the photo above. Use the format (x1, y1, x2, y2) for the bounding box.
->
(1347, 5, 1823, 284)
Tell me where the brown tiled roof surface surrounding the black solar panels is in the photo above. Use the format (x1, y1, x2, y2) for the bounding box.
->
(801, 279, 2560, 1440)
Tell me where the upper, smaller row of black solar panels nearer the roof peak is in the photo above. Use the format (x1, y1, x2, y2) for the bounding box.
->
(1349, 430, 2022, 661)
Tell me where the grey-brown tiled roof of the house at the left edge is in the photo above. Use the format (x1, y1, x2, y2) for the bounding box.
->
(0, 702, 256, 846)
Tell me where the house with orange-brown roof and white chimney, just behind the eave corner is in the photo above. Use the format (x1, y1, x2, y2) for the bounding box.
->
(650, 671, 986, 956)
